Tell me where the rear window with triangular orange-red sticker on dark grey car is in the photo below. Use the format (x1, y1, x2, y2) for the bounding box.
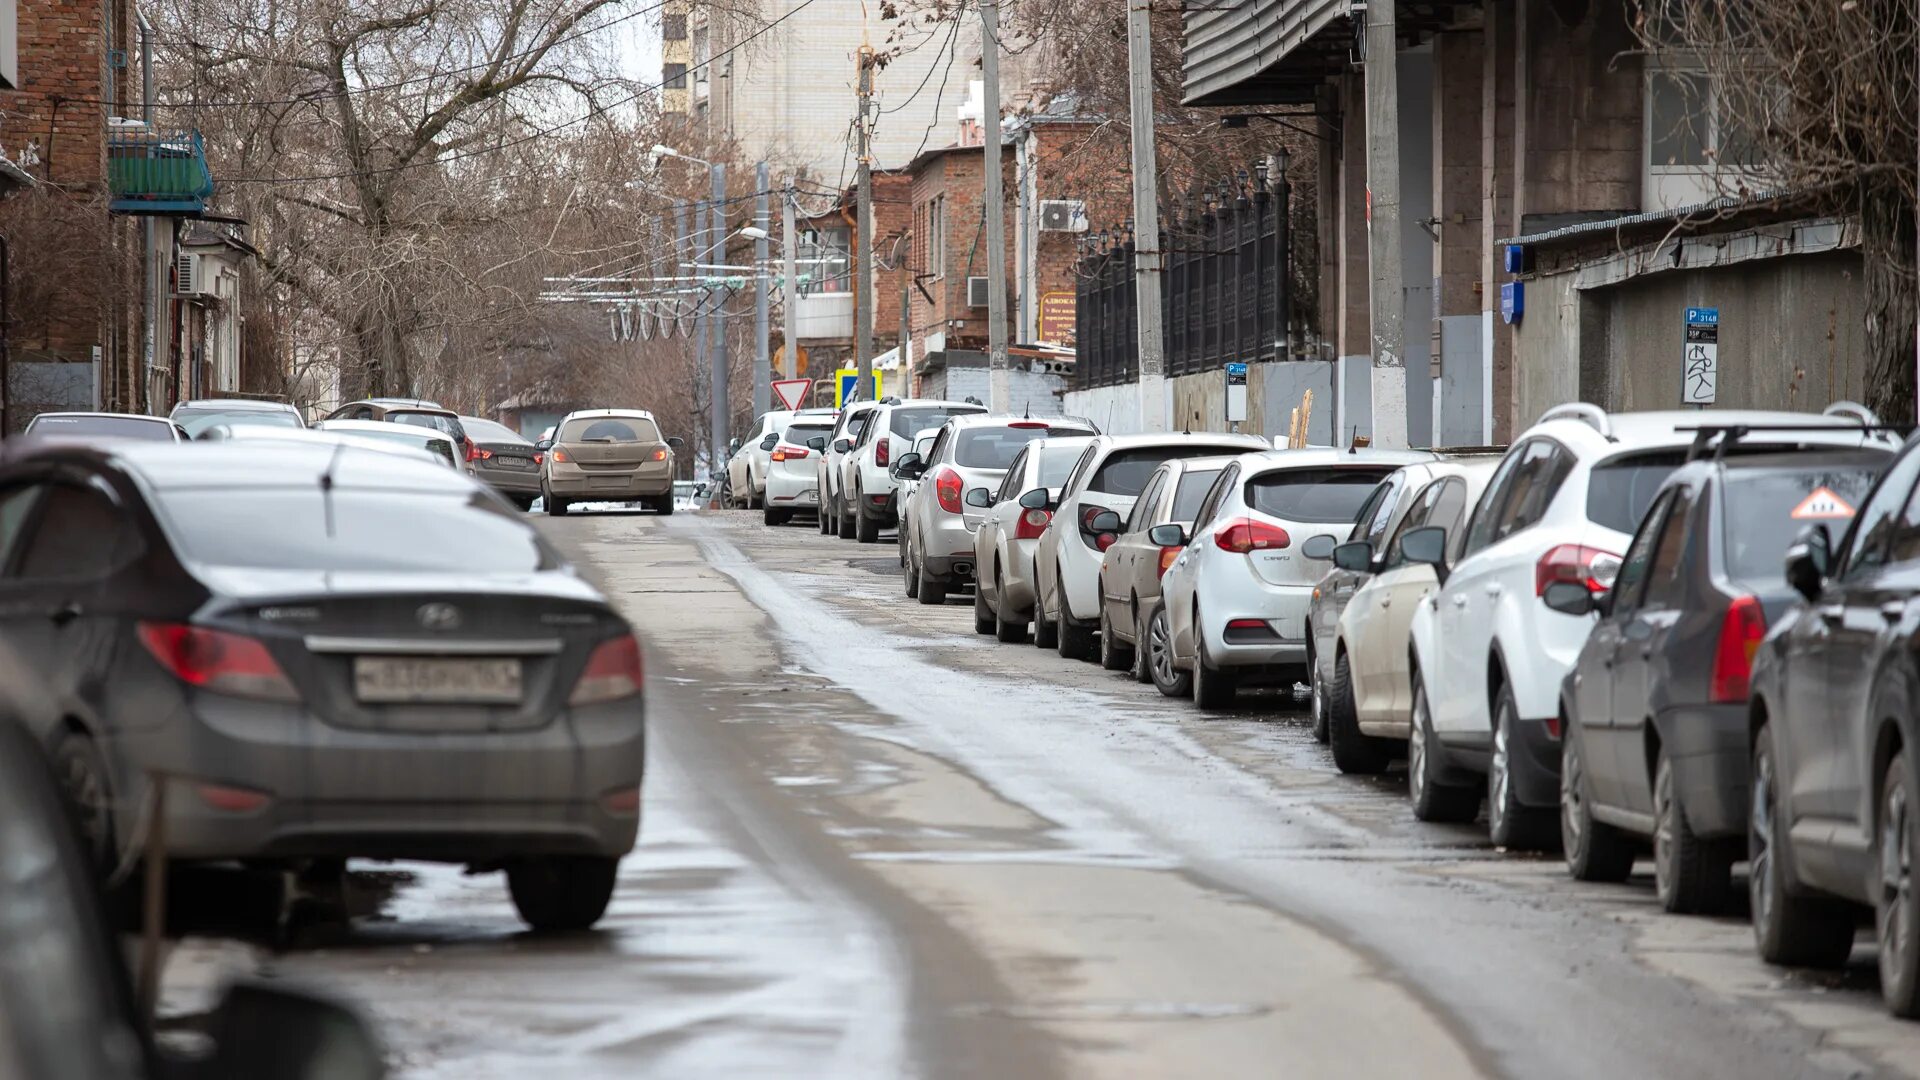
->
(1722, 463, 1880, 584)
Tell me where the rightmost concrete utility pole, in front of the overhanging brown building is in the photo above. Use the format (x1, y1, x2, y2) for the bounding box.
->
(1365, 0, 1407, 450)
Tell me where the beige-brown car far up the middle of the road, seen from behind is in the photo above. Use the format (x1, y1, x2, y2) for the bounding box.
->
(534, 409, 682, 515)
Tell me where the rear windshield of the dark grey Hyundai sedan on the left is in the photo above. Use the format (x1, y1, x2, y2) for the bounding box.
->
(157, 484, 559, 573)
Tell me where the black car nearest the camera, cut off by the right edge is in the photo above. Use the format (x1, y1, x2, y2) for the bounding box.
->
(1747, 426, 1920, 1017)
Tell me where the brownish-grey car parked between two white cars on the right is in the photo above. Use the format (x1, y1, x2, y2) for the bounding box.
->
(1100, 457, 1233, 682)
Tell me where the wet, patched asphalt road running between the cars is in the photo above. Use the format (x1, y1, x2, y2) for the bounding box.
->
(169, 513, 1920, 1080)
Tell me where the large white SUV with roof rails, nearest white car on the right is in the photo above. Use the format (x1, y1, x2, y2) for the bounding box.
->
(1402, 404, 1893, 847)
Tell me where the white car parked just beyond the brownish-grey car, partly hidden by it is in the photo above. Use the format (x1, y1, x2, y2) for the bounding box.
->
(1033, 432, 1269, 661)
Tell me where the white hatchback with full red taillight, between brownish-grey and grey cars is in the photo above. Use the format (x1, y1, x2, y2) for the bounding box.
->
(1148, 450, 1432, 709)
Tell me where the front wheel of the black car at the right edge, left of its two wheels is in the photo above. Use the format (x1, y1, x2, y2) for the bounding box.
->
(1747, 724, 1853, 969)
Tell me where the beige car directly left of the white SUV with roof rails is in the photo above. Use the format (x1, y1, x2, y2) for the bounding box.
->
(1315, 455, 1500, 773)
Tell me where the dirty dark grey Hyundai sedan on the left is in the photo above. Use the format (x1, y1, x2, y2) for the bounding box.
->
(0, 440, 643, 930)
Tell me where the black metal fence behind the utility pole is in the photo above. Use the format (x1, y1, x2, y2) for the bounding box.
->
(1071, 184, 1292, 390)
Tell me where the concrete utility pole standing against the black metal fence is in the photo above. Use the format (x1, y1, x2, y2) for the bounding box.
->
(1127, 0, 1167, 430)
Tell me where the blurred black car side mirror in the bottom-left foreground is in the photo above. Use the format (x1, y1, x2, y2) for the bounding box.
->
(199, 982, 386, 1080)
